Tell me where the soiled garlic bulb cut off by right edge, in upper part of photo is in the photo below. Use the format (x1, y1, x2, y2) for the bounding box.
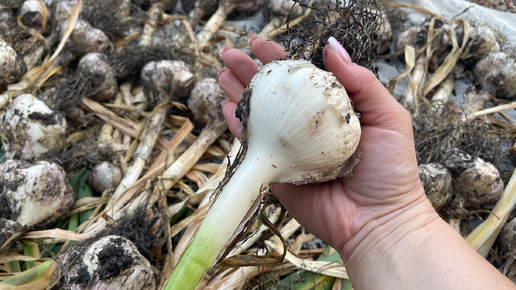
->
(473, 52, 516, 99)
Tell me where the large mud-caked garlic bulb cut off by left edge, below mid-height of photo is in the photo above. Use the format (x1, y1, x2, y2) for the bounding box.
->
(0, 160, 75, 250)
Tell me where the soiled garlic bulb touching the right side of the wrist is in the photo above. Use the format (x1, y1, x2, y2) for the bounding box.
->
(419, 163, 452, 210)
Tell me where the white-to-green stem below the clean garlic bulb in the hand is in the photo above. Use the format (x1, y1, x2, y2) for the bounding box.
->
(165, 156, 275, 290)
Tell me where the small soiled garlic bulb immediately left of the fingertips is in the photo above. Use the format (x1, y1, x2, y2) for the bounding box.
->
(188, 78, 226, 127)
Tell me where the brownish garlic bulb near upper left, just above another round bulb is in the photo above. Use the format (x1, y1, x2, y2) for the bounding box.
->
(61, 20, 112, 57)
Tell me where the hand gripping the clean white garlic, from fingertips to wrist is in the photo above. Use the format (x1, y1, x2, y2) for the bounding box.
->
(219, 37, 433, 261)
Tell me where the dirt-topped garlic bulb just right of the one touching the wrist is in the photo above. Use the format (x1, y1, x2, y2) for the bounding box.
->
(444, 149, 504, 208)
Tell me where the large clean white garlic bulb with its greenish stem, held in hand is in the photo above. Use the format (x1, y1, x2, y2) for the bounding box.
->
(165, 60, 361, 290)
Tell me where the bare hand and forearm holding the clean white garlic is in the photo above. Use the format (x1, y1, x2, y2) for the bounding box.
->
(219, 37, 516, 289)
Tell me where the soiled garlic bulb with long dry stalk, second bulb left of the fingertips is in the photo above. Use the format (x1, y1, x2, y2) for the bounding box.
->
(106, 60, 196, 208)
